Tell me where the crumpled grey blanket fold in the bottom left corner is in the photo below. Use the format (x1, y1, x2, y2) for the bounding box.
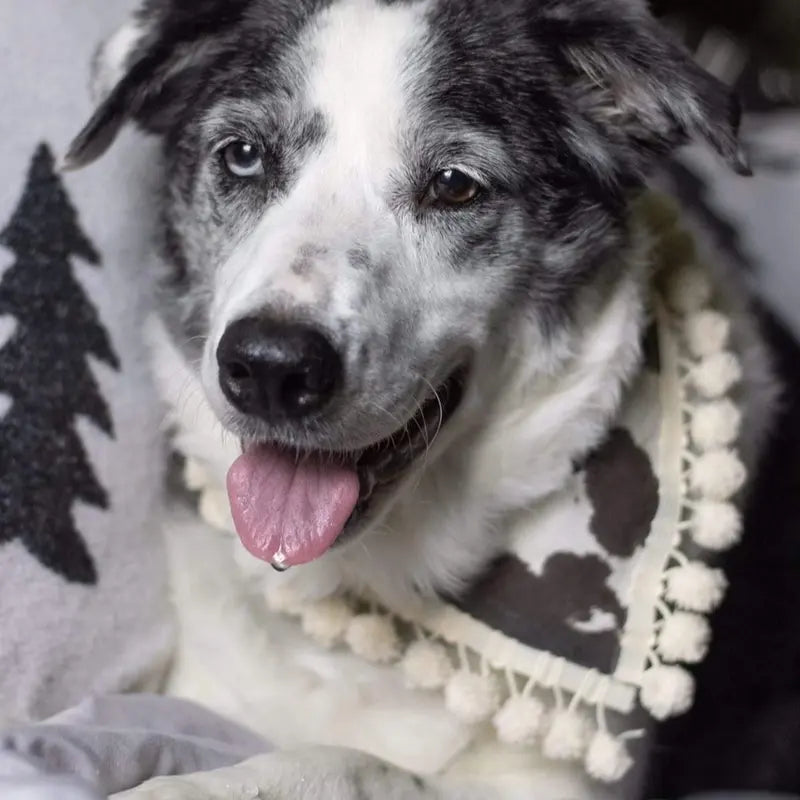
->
(0, 694, 267, 800)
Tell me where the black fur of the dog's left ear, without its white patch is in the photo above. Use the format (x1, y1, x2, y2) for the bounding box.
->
(62, 0, 250, 170)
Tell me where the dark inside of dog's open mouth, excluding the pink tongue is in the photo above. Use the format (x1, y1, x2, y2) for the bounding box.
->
(234, 363, 469, 568)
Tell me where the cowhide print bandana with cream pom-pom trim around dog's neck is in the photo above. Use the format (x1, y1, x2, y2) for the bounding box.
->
(187, 195, 746, 783)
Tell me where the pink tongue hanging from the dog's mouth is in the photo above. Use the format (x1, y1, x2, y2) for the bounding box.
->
(228, 445, 359, 567)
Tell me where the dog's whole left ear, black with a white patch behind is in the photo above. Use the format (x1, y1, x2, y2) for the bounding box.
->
(63, 0, 249, 169)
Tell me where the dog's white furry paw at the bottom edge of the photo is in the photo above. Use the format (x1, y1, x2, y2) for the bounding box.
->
(113, 748, 439, 800)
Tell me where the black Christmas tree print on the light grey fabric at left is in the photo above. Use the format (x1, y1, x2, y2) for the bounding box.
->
(0, 145, 118, 584)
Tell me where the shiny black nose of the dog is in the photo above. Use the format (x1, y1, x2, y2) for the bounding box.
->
(217, 317, 342, 422)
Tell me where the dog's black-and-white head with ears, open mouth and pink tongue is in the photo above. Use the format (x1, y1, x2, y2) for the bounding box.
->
(70, 0, 738, 564)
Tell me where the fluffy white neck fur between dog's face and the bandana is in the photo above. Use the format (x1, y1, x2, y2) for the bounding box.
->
(151, 216, 650, 605)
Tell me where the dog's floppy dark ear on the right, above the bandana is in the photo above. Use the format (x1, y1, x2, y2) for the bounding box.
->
(544, 0, 750, 175)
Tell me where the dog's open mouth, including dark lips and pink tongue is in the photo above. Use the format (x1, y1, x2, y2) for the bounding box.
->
(223, 366, 468, 568)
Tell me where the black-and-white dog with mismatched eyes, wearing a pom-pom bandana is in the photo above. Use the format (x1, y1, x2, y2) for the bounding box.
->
(66, 0, 792, 800)
